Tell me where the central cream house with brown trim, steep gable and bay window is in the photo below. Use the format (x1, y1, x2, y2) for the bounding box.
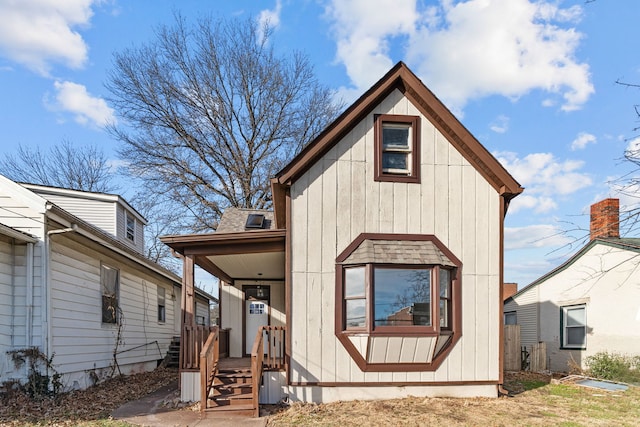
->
(161, 63, 523, 409)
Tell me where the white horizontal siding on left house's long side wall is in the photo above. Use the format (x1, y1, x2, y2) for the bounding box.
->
(50, 235, 180, 389)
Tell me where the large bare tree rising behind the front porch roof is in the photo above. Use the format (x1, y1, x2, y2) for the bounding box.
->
(107, 15, 342, 231)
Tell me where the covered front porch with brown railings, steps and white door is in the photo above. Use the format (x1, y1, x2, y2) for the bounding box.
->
(161, 217, 288, 416)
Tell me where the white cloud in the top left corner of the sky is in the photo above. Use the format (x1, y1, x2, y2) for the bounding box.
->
(0, 0, 99, 76)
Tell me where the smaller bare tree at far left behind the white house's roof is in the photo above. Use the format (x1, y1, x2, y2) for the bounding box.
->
(0, 140, 117, 193)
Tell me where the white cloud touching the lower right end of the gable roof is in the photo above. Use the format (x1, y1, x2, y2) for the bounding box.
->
(494, 152, 592, 213)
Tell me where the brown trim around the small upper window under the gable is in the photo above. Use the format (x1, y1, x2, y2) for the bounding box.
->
(374, 114, 420, 183)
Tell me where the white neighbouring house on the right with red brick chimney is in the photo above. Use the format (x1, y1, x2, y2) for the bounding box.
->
(504, 199, 640, 372)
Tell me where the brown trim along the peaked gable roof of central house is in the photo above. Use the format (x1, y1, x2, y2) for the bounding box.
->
(274, 62, 523, 200)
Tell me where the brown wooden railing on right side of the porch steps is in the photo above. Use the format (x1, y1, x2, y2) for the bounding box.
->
(251, 326, 286, 418)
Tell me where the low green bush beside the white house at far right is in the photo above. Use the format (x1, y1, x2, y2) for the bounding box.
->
(585, 351, 640, 383)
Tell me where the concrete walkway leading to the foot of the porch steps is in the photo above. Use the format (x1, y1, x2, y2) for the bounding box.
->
(111, 382, 267, 427)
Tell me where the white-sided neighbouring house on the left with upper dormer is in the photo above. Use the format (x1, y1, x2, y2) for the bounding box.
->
(0, 175, 213, 389)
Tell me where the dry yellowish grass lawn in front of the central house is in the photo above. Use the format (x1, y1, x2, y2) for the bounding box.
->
(268, 373, 640, 427)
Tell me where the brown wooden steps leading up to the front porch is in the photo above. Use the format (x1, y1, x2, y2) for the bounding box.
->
(206, 367, 255, 416)
